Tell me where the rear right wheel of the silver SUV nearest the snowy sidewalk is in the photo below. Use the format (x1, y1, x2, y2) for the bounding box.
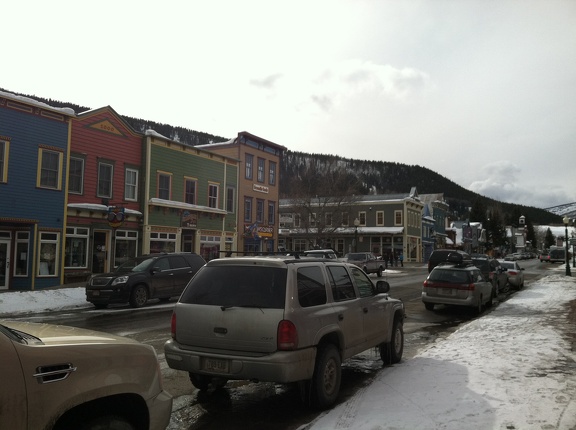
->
(312, 344, 342, 409)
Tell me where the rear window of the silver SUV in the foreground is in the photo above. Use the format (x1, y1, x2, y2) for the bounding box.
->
(180, 266, 287, 309)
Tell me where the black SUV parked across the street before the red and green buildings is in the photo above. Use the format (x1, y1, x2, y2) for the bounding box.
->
(86, 253, 206, 308)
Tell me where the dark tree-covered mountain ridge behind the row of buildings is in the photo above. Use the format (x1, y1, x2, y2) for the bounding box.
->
(0, 88, 564, 225)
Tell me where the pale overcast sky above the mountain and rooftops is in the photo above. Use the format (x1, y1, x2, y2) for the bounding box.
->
(0, 0, 576, 208)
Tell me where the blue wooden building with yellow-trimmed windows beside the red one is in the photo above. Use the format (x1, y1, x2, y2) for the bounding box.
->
(0, 91, 75, 290)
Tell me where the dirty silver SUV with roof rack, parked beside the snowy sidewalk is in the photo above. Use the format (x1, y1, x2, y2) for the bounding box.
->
(164, 256, 404, 408)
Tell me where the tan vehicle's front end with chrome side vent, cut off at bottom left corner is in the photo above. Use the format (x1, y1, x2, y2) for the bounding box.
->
(0, 320, 172, 430)
